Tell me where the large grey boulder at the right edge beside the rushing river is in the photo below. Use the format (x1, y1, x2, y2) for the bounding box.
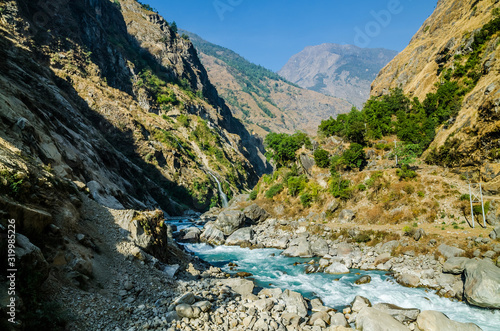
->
(464, 260, 500, 309)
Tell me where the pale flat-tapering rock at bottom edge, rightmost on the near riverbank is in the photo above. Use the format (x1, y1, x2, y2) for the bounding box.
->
(417, 310, 481, 331)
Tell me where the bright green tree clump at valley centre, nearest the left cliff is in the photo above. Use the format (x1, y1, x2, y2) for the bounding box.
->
(264, 132, 312, 166)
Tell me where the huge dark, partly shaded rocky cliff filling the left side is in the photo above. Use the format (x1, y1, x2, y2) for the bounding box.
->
(0, 0, 268, 218)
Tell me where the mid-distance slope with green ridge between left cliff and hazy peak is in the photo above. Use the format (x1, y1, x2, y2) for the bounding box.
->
(182, 31, 351, 136)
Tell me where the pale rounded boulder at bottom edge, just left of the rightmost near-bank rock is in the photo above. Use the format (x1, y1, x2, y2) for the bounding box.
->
(356, 307, 408, 331)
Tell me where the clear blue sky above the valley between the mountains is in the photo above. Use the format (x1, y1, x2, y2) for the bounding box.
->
(146, 0, 437, 71)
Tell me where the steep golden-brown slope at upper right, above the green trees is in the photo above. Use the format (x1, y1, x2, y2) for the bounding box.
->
(371, 0, 500, 174)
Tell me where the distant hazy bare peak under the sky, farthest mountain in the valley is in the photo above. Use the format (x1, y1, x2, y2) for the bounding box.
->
(278, 44, 397, 108)
